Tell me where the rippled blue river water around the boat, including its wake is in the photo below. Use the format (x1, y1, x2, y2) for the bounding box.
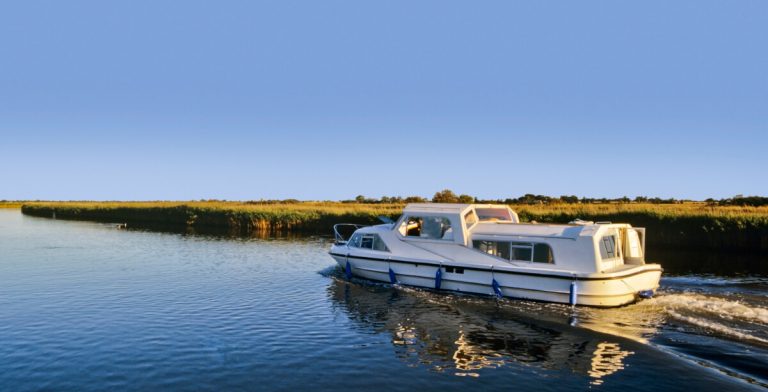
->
(0, 210, 768, 391)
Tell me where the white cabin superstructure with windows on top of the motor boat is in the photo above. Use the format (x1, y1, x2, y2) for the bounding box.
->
(392, 203, 645, 272)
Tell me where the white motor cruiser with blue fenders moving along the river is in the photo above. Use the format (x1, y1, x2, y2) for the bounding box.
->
(330, 203, 662, 307)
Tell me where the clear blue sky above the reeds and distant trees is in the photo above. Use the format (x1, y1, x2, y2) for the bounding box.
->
(0, 0, 768, 200)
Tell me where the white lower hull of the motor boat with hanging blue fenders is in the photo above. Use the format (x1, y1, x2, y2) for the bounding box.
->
(331, 254, 661, 307)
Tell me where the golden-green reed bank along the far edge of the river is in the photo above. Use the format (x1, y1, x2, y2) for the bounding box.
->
(22, 202, 768, 251)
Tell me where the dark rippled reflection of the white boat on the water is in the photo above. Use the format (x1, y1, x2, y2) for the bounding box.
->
(328, 279, 652, 385)
